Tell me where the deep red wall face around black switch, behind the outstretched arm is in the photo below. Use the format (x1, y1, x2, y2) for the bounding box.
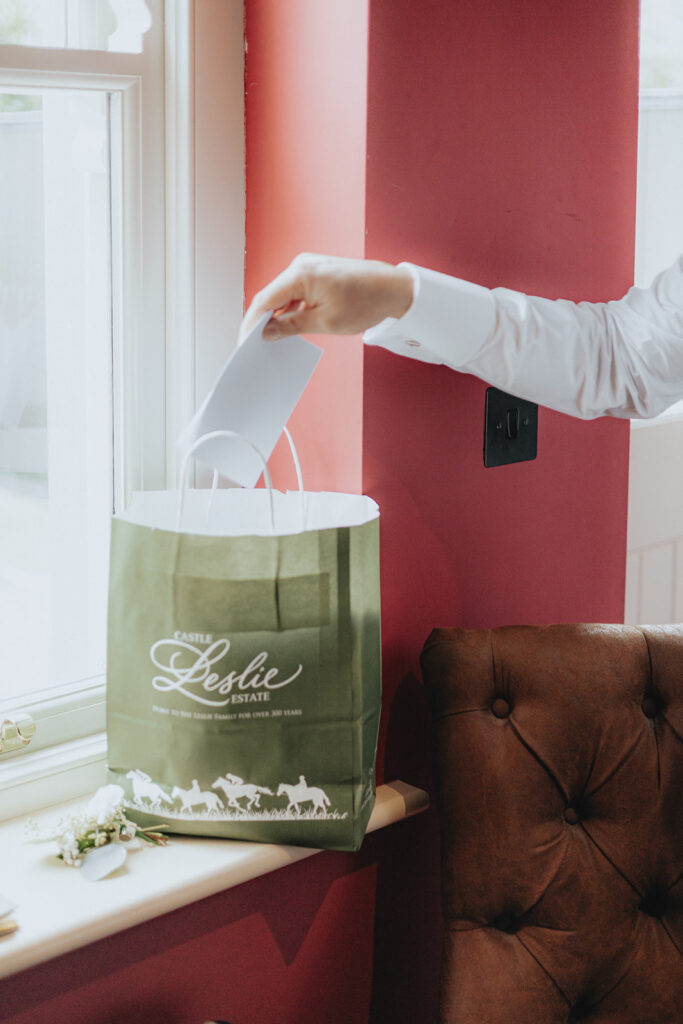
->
(364, 0, 637, 770)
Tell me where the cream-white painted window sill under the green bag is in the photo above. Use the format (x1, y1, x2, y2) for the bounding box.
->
(0, 781, 429, 977)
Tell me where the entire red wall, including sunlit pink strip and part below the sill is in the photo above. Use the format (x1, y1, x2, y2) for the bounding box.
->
(0, 0, 637, 1024)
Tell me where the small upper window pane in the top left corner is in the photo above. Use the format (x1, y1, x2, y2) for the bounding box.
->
(0, 0, 152, 53)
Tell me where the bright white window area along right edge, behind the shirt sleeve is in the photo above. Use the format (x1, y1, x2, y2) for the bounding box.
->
(626, 0, 683, 624)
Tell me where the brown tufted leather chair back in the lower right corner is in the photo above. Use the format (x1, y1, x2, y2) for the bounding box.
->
(422, 626, 683, 1024)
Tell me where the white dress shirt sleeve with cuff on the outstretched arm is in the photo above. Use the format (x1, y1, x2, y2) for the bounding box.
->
(364, 256, 683, 419)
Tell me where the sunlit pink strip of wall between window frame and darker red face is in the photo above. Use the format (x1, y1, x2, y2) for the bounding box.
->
(245, 0, 368, 494)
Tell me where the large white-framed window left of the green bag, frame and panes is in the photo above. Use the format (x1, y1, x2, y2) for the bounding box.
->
(0, 0, 244, 816)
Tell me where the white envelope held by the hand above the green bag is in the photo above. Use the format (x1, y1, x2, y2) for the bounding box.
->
(178, 313, 323, 487)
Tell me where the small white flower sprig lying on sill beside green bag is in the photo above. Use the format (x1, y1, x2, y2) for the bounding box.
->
(27, 785, 168, 867)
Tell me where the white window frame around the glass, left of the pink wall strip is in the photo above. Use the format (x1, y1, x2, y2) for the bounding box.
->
(0, 0, 245, 819)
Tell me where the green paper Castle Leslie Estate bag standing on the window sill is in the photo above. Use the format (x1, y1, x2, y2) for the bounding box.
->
(108, 440, 381, 850)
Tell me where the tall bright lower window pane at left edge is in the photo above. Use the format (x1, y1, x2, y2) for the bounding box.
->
(0, 90, 113, 702)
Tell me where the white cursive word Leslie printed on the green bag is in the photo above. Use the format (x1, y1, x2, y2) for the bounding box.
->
(150, 633, 303, 708)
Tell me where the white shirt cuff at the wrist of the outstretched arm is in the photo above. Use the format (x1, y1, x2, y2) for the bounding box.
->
(362, 263, 496, 370)
